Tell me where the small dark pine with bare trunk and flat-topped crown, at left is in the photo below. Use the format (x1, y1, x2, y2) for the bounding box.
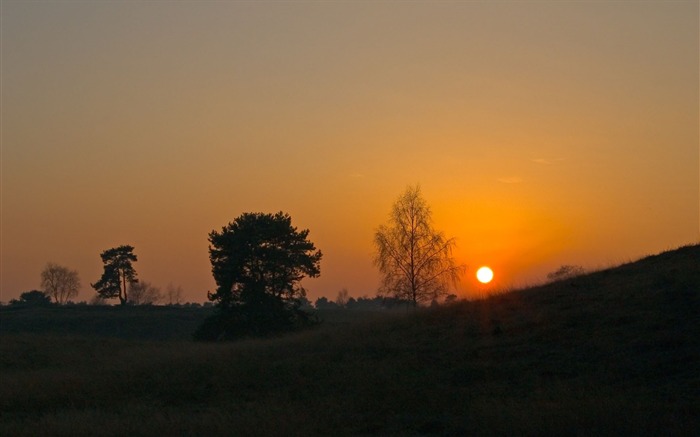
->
(90, 246, 138, 305)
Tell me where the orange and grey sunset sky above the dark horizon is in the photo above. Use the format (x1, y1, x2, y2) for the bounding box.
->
(0, 1, 700, 302)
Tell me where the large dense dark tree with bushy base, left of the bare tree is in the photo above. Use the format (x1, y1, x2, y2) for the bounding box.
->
(195, 212, 322, 340)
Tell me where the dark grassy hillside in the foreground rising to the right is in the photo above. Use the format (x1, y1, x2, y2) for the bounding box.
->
(0, 246, 700, 436)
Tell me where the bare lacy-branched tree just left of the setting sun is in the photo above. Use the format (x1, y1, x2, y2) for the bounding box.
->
(374, 186, 466, 306)
